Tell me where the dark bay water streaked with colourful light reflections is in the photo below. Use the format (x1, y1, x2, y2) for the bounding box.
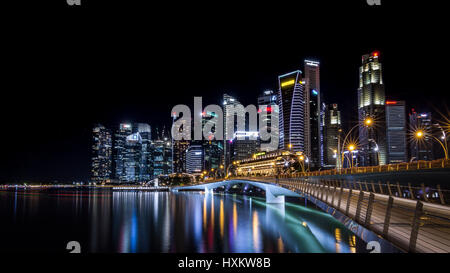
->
(0, 189, 365, 253)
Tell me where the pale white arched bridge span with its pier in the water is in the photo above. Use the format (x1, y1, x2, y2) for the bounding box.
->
(172, 180, 303, 203)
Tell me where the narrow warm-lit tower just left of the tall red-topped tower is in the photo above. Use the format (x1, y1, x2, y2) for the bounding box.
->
(323, 103, 341, 167)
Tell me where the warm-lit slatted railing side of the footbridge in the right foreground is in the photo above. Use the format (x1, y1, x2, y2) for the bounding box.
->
(278, 178, 450, 253)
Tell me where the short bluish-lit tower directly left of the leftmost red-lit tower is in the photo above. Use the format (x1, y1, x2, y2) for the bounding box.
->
(152, 134, 172, 177)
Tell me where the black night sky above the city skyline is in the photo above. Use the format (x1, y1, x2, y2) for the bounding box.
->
(0, 0, 450, 183)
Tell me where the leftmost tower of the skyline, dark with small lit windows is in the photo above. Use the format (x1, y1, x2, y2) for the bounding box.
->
(91, 124, 112, 183)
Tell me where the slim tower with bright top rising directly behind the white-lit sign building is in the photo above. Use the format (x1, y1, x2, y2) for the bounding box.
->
(223, 94, 244, 169)
